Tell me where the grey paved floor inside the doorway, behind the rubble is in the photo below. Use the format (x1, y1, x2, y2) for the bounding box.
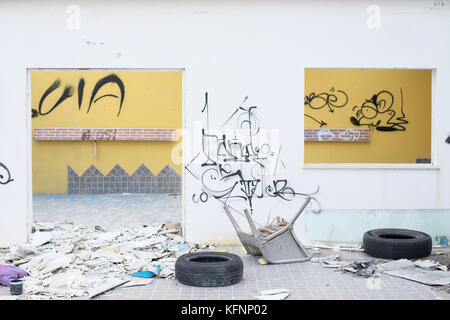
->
(33, 194, 181, 228)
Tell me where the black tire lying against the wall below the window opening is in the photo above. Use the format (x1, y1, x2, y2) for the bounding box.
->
(363, 229, 432, 259)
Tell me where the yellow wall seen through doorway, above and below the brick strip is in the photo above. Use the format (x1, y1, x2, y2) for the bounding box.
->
(31, 70, 182, 193)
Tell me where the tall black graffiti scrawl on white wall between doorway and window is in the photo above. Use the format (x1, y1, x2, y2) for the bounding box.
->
(185, 93, 319, 213)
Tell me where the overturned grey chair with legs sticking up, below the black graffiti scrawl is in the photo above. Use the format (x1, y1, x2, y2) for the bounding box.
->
(224, 196, 311, 264)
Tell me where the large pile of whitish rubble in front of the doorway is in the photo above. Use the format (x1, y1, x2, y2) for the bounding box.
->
(0, 222, 211, 299)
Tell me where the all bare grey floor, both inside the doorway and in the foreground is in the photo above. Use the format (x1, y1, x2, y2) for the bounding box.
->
(0, 195, 450, 300)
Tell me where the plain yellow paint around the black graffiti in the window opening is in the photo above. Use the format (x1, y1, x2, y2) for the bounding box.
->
(304, 69, 431, 163)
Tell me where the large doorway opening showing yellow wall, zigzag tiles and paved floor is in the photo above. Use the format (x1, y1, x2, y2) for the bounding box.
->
(28, 69, 183, 228)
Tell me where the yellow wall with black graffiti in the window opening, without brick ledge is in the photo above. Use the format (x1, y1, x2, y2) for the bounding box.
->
(304, 69, 431, 163)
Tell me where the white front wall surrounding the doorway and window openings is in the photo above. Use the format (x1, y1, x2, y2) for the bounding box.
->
(0, 1, 450, 245)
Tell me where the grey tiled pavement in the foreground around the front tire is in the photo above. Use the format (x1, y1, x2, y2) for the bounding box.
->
(92, 246, 450, 300)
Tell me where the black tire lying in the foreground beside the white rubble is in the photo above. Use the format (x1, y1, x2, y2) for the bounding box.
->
(175, 252, 244, 287)
